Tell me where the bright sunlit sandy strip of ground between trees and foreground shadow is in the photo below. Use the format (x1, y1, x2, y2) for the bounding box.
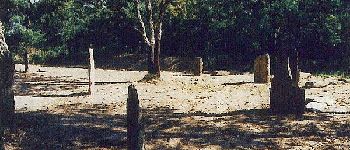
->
(15, 65, 350, 113)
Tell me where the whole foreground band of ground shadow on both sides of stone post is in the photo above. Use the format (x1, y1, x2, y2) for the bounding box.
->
(5, 104, 350, 149)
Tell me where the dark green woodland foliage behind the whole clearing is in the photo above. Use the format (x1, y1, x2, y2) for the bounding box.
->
(0, 0, 350, 73)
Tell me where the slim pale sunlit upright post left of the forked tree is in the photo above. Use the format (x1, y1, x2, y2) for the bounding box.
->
(89, 46, 96, 96)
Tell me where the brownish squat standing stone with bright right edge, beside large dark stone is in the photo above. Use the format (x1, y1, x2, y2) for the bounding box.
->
(254, 54, 270, 83)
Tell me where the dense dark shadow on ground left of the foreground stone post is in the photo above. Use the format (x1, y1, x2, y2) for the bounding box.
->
(7, 106, 126, 149)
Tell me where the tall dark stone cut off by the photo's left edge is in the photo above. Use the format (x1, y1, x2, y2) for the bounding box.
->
(0, 21, 15, 126)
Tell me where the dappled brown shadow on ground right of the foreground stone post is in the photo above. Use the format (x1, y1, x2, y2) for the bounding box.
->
(146, 108, 350, 149)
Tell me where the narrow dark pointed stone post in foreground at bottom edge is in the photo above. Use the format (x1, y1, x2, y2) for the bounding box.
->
(127, 85, 144, 150)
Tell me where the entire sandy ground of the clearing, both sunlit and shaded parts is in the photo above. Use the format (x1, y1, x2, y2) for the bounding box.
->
(5, 65, 350, 149)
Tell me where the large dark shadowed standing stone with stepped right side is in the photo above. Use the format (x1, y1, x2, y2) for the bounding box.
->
(270, 52, 305, 114)
